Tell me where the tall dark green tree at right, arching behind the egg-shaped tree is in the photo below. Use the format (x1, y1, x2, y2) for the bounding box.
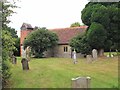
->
(81, 2, 120, 54)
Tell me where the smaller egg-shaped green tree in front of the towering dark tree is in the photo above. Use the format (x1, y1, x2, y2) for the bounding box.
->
(87, 22, 107, 56)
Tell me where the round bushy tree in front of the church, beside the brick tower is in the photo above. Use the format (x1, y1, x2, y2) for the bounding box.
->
(24, 28, 58, 57)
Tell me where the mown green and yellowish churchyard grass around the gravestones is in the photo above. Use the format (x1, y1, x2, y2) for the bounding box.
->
(8, 57, 118, 88)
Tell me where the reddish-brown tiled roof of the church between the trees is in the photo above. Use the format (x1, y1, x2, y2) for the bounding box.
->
(49, 26, 87, 44)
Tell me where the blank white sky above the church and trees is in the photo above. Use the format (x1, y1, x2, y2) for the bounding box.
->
(9, 0, 89, 37)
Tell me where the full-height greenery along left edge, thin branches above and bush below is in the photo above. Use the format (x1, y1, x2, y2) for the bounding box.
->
(0, 0, 16, 87)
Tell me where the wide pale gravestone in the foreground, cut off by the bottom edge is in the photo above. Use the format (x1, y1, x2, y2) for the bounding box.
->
(72, 77, 91, 88)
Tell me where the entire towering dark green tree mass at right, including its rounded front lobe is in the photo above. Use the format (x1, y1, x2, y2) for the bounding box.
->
(69, 2, 120, 53)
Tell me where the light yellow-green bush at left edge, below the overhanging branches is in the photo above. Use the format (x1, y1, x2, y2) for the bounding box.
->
(2, 30, 15, 87)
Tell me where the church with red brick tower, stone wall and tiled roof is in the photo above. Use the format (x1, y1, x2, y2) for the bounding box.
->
(20, 23, 87, 58)
